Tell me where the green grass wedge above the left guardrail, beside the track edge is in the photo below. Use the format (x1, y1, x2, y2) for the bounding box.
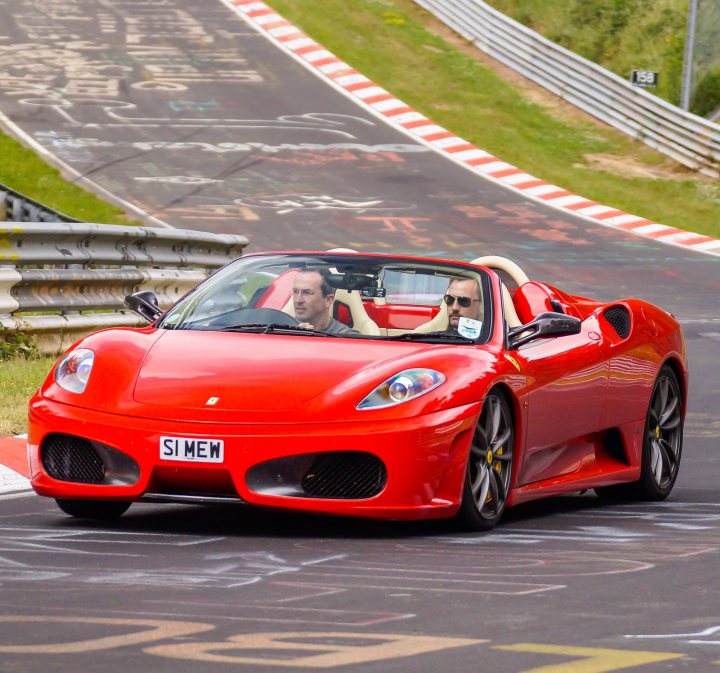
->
(0, 133, 140, 225)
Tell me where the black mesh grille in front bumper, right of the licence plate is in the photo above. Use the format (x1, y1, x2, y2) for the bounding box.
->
(302, 451, 387, 500)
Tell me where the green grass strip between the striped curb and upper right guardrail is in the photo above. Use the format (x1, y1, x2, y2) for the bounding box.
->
(270, 0, 720, 237)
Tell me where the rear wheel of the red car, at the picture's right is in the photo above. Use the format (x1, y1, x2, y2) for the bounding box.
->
(595, 366, 684, 501)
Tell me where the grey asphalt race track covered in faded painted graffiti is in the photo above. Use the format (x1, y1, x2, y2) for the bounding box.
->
(0, 0, 720, 673)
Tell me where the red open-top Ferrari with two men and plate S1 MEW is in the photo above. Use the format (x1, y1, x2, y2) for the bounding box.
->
(28, 250, 687, 530)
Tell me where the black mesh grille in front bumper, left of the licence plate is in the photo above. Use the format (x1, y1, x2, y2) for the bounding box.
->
(40, 435, 105, 484)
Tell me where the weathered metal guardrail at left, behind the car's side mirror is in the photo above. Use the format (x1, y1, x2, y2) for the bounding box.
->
(0, 223, 248, 353)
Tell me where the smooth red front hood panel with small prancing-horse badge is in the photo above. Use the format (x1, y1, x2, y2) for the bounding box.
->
(133, 331, 390, 411)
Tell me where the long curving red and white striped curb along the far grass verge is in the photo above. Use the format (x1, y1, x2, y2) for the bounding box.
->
(221, 0, 720, 256)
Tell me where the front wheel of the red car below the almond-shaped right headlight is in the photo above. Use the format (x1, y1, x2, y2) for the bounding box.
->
(456, 390, 515, 531)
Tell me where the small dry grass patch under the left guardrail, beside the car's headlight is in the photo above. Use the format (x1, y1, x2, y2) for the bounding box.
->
(0, 356, 56, 437)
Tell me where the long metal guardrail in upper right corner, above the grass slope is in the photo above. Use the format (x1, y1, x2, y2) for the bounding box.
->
(414, 0, 720, 178)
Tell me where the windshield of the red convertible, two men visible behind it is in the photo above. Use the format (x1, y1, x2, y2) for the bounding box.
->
(157, 253, 492, 344)
